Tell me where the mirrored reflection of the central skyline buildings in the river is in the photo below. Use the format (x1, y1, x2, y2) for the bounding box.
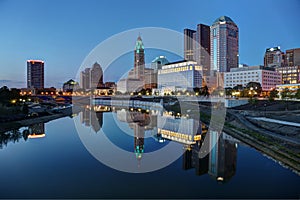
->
(80, 105, 238, 182)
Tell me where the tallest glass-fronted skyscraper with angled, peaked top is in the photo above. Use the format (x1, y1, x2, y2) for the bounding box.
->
(210, 16, 239, 72)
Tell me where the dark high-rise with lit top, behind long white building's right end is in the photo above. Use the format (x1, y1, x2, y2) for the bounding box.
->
(264, 46, 285, 68)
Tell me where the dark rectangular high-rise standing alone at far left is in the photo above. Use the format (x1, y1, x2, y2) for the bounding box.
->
(27, 60, 44, 89)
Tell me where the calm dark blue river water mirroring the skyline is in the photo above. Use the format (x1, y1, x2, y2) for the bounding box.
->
(0, 107, 300, 199)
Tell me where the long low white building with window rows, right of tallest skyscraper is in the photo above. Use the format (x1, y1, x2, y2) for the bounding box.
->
(224, 66, 281, 91)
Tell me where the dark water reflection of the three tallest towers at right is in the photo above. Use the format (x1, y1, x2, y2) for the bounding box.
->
(183, 131, 238, 182)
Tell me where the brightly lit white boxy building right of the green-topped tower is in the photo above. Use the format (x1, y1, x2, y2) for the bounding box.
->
(158, 60, 202, 93)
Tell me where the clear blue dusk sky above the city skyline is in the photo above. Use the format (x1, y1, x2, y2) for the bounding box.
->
(0, 0, 300, 88)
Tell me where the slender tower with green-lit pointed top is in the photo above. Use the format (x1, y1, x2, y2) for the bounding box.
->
(134, 36, 145, 80)
